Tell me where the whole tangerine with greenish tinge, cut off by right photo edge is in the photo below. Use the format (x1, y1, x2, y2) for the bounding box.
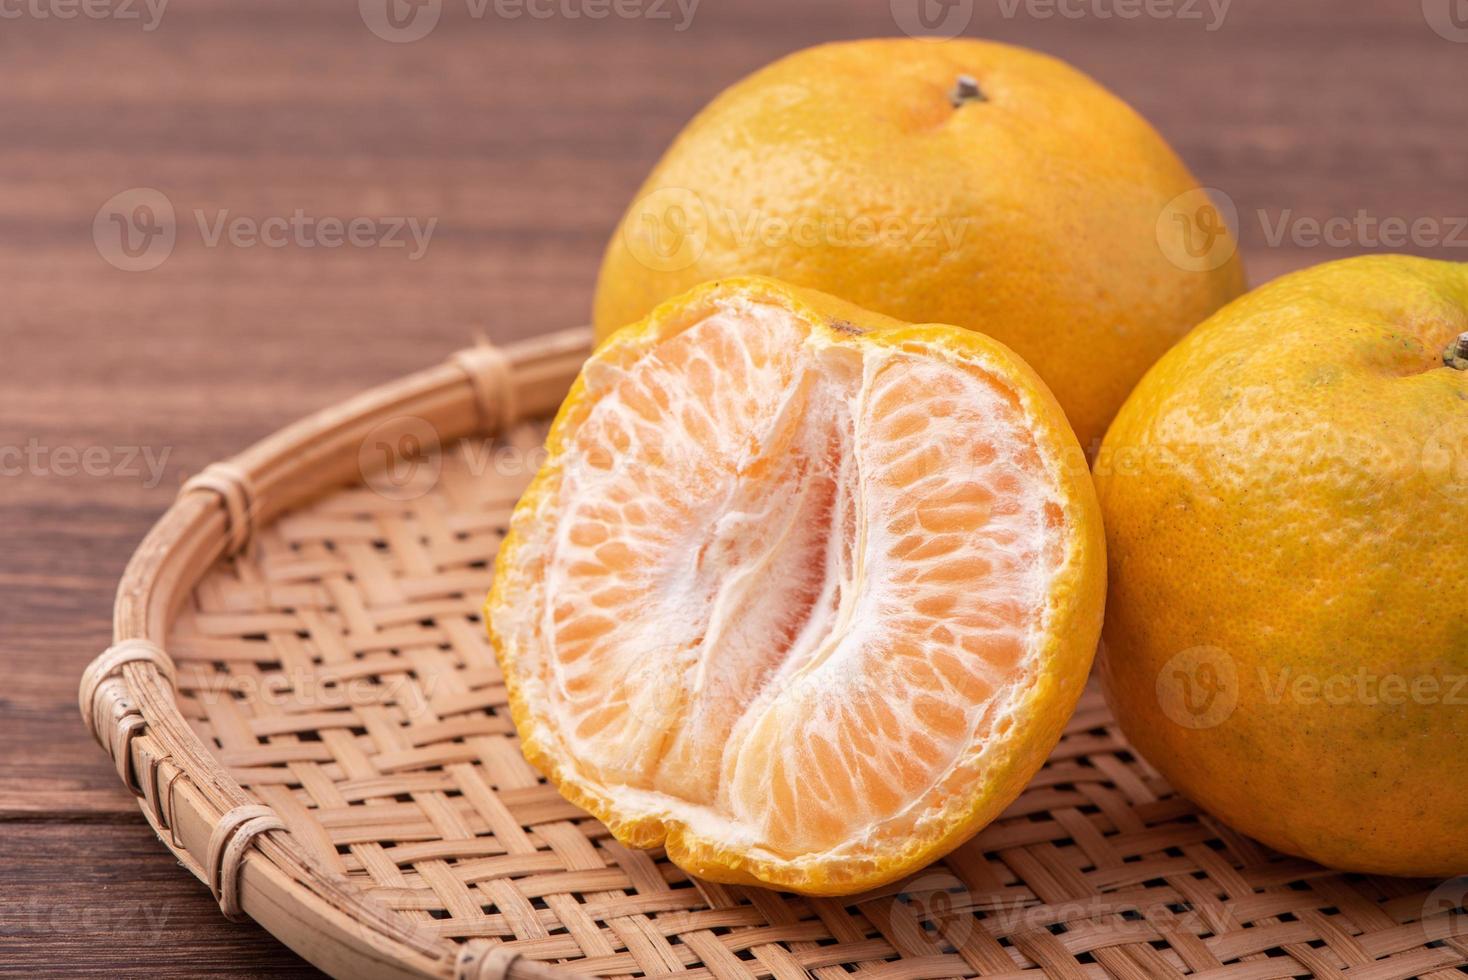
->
(1095, 257, 1468, 874)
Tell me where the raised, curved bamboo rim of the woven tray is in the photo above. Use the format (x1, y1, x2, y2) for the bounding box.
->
(78, 327, 592, 980)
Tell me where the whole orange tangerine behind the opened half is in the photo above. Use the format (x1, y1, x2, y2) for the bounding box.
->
(595, 40, 1243, 452)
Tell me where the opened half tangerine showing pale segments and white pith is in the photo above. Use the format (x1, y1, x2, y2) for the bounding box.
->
(486, 279, 1105, 895)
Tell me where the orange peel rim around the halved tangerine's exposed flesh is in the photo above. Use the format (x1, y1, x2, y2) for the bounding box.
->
(484, 276, 1105, 895)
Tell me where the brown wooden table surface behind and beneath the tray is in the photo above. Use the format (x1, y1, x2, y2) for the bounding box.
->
(0, 0, 1468, 977)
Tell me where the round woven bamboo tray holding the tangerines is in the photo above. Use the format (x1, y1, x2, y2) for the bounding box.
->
(81, 330, 1468, 980)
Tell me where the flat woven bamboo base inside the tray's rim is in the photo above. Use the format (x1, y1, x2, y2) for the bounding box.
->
(166, 424, 1468, 980)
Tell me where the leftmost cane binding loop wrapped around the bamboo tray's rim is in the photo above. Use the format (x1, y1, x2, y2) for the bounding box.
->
(76, 640, 176, 803)
